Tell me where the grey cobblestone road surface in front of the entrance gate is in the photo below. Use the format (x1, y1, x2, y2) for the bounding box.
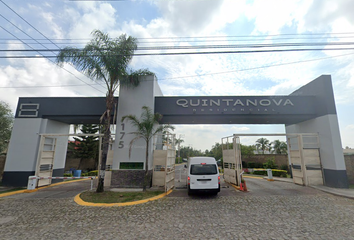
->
(0, 179, 354, 239)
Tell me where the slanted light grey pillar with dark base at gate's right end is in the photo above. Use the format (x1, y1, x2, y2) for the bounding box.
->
(285, 75, 349, 188)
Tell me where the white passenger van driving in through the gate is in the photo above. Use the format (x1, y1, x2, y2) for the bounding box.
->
(187, 157, 220, 195)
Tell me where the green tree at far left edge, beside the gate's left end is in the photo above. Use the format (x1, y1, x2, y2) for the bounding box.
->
(0, 101, 13, 154)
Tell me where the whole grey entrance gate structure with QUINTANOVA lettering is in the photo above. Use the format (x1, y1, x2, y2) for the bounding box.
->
(2, 75, 349, 188)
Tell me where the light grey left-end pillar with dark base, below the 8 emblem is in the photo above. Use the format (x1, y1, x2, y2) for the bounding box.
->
(3, 118, 69, 186)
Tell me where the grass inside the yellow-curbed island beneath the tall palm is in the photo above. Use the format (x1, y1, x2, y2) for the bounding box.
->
(80, 191, 164, 203)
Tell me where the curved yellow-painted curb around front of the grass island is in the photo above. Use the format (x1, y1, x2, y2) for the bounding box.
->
(74, 189, 173, 207)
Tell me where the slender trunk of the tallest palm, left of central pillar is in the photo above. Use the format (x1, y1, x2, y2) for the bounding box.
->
(96, 91, 114, 192)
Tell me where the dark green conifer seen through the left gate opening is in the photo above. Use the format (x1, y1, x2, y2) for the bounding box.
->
(68, 124, 99, 169)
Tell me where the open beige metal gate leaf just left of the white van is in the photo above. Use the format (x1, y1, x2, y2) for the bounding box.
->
(152, 134, 176, 192)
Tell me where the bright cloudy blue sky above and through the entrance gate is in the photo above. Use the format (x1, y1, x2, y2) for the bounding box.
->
(0, 0, 354, 151)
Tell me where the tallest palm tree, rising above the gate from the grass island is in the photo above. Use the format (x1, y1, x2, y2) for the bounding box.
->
(57, 30, 151, 192)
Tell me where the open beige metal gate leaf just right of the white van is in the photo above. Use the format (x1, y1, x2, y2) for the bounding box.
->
(221, 136, 242, 186)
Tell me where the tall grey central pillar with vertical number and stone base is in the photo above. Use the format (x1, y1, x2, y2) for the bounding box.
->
(111, 76, 162, 187)
